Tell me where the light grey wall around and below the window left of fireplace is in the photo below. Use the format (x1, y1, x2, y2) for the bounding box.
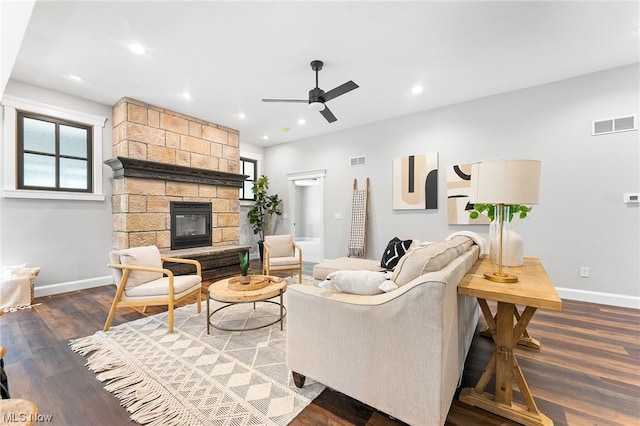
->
(0, 80, 112, 296)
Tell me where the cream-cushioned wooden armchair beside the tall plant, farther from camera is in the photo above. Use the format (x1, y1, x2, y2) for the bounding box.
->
(262, 234, 302, 284)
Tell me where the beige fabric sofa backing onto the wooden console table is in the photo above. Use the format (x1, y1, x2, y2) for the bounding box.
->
(285, 237, 480, 426)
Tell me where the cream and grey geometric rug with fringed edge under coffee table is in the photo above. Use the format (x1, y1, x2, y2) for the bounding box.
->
(70, 288, 325, 426)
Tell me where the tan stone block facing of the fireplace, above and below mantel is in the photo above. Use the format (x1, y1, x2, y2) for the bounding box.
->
(112, 98, 240, 250)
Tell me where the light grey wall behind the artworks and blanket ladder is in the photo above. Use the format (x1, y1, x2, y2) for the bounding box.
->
(264, 64, 640, 307)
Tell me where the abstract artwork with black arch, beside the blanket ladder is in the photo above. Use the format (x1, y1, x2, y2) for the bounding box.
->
(393, 152, 438, 210)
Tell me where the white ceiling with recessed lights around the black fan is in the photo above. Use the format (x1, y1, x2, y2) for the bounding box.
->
(7, 0, 640, 146)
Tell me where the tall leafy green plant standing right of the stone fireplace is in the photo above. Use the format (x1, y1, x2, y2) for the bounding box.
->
(247, 175, 282, 260)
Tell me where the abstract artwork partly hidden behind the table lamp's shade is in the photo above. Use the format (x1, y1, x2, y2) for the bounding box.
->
(447, 163, 490, 225)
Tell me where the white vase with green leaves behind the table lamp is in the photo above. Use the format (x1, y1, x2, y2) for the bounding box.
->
(469, 203, 532, 266)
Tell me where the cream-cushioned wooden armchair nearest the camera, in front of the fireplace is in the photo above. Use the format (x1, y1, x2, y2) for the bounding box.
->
(104, 246, 202, 333)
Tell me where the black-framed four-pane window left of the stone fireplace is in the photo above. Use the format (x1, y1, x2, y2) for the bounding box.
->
(17, 111, 93, 192)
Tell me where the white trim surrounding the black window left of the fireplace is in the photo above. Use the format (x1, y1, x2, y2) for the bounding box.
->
(2, 95, 107, 201)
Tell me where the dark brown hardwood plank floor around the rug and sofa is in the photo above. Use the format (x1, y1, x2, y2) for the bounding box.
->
(0, 280, 640, 426)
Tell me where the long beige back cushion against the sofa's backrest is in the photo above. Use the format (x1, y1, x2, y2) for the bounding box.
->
(391, 236, 472, 286)
